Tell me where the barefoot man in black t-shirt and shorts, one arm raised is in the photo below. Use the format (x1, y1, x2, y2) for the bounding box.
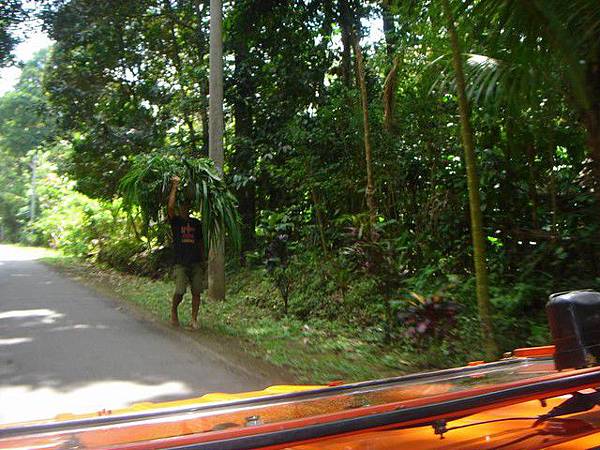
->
(167, 176, 206, 329)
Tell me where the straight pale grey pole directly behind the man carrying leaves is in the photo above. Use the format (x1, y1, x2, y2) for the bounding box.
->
(208, 0, 225, 300)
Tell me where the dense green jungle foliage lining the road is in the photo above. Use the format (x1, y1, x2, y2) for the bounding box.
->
(0, 0, 600, 364)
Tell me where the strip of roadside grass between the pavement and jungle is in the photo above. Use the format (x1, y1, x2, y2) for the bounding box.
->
(42, 255, 447, 383)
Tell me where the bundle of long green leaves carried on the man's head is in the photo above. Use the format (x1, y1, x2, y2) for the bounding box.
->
(119, 155, 241, 249)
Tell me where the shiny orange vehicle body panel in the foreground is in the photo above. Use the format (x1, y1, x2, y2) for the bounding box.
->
(0, 356, 600, 450)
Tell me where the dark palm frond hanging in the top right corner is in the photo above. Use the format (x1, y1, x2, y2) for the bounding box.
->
(462, 0, 600, 109)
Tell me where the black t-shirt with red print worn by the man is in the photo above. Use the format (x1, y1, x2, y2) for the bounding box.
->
(171, 216, 204, 266)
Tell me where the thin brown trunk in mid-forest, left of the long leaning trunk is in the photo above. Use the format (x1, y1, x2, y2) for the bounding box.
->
(350, 31, 377, 234)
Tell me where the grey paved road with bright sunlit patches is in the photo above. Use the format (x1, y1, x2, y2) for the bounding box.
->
(0, 246, 272, 423)
